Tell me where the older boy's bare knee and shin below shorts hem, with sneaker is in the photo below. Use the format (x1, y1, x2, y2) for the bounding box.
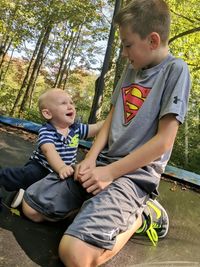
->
(59, 199, 169, 267)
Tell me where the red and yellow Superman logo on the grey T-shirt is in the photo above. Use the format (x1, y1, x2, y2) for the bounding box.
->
(122, 84, 150, 123)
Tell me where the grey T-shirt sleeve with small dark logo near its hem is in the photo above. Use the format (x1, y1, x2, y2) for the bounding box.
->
(159, 59, 191, 123)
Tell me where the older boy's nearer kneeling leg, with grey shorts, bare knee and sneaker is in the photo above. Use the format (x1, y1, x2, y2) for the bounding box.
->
(59, 179, 169, 267)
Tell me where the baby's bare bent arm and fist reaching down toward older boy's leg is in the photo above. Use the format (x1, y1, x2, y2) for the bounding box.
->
(40, 143, 74, 179)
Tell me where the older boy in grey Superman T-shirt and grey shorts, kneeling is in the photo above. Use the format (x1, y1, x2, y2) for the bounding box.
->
(24, 0, 190, 267)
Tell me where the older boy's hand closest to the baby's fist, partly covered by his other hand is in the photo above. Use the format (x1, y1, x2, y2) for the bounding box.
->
(74, 158, 96, 181)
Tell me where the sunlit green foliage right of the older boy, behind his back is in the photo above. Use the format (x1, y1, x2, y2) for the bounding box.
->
(168, 0, 200, 173)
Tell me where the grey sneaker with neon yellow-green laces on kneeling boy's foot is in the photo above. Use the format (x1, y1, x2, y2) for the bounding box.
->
(136, 199, 169, 246)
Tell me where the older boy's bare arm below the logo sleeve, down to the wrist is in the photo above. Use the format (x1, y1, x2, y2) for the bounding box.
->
(107, 114, 179, 180)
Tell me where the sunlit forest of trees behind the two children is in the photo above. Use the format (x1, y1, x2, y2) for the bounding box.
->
(0, 0, 200, 173)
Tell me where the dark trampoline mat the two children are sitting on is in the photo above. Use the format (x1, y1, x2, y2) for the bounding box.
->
(0, 125, 200, 267)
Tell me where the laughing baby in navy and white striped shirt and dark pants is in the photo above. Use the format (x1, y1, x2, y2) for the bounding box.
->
(0, 88, 102, 207)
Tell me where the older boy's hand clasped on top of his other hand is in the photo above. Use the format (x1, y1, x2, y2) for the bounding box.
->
(79, 166, 113, 195)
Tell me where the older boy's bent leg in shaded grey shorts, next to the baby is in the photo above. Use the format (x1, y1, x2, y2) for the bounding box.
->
(22, 173, 89, 222)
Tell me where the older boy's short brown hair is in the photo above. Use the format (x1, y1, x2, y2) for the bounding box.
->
(114, 0, 170, 44)
